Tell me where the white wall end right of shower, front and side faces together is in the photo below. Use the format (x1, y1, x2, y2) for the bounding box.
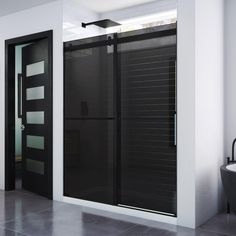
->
(178, 0, 224, 227)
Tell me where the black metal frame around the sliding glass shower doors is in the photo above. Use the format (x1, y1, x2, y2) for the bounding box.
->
(63, 23, 178, 214)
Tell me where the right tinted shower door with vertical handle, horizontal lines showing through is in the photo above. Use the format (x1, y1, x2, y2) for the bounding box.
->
(118, 26, 176, 215)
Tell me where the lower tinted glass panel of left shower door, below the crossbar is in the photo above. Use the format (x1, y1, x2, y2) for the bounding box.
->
(65, 119, 114, 204)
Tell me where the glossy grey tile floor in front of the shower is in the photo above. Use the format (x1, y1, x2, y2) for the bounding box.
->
(0, 191, 233, 236)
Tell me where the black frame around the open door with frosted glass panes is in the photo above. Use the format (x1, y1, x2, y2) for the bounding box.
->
(5, 30, 53, 199)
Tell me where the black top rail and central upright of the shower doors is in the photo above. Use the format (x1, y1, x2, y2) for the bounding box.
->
(63, 24, 177, 215)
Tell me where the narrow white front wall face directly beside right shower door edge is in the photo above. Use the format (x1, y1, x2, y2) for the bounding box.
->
(177, 0, 196, 227)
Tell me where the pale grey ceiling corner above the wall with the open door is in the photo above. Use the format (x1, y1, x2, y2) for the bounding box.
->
(0, 0, 54, 16)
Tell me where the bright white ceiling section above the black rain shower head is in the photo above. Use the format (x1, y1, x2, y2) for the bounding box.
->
(74, 0, 157, 13)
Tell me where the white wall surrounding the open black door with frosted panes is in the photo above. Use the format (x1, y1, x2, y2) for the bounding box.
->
(0, 0, 63, 199)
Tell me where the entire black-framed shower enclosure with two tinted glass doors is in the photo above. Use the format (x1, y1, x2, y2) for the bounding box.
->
(64, 24, 177, 216)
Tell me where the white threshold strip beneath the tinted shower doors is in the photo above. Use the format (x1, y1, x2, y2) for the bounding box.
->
(63, 197, 177, 225)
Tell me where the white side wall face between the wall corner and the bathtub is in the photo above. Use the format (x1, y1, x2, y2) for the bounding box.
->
(195, 0, 224, 226)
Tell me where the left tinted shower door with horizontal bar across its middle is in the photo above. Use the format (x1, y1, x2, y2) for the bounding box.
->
(64, 36, 115, 204)
